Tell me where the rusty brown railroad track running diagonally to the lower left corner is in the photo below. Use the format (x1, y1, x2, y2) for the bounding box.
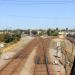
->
(0, 39, 38, 75)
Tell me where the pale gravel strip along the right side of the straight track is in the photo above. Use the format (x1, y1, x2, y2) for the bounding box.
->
(49, 39, 65, 75)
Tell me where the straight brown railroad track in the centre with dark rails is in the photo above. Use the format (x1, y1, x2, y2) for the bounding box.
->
(33, 38, 50, 75)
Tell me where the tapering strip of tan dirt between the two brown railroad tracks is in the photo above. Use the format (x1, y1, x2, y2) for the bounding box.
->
(19, 48, 36, 75)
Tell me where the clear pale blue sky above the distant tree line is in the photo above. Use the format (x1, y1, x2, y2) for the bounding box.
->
(0, 0, 75, 29)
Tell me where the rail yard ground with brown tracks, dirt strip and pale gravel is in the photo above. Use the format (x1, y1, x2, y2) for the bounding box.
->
(0, 37, 74, 75)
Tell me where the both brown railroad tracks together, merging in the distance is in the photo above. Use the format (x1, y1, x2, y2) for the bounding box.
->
(0, 37, 50, 75)
